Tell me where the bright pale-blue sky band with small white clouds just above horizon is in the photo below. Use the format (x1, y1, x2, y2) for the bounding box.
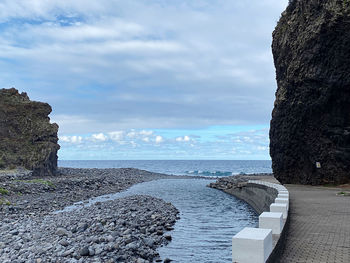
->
(56, 127, 269, 159)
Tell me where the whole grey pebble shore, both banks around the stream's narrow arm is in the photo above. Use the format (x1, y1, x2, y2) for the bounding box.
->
(0, 168, 183, 263)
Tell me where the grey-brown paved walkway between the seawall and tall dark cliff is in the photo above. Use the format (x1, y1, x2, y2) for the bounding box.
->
(280, 185, 350, 263)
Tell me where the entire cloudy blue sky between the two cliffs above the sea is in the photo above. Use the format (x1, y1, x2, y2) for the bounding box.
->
(0, 0, 288, 160)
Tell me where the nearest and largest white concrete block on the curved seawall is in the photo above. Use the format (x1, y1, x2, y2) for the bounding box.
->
(232, 227, 272, 263)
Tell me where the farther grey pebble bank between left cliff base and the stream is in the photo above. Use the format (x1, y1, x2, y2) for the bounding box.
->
(0, 167, 201, 216)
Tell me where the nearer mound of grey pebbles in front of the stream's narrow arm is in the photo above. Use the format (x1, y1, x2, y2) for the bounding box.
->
(0, 196, 178, 263)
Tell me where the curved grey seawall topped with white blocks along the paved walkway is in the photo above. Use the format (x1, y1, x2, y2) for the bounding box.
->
(211, 180, 290, 263)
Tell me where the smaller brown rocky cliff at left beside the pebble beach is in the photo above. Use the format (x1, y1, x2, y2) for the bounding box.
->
(0, 88, 60, 175)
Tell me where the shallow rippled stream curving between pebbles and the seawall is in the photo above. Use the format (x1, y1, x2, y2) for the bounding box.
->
(57, 179, 258, 263)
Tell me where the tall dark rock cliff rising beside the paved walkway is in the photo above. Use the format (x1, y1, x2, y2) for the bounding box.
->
(270, 0, 350, 184)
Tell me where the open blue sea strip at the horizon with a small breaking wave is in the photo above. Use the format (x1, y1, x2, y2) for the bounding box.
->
(58, 160, 272, 176)
